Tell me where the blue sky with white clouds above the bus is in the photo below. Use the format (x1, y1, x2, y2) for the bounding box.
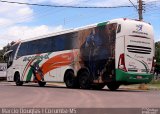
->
(0, 0, 160, 49)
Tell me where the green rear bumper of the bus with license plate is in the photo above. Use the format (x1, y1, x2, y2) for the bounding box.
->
(116, 69, 153, 84)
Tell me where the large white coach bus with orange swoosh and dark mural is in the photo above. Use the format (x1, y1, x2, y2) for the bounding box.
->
(4, 18, 154, 91)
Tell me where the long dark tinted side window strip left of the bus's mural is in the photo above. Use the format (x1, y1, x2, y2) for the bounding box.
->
(18, 32, 78, 57)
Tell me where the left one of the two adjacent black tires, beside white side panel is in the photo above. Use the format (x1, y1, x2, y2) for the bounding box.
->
(64, 70, 79, 88)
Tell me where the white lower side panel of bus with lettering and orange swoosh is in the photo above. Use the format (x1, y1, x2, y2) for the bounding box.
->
(19, 50, 73, 82)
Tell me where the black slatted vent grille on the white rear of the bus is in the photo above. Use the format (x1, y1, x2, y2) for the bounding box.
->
(127, 45, 152, 54)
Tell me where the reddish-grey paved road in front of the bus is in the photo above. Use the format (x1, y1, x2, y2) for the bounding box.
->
(0, 82, 160, 108)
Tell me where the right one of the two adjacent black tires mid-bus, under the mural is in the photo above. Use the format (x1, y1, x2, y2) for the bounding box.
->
(79, 70, 91, 89)
